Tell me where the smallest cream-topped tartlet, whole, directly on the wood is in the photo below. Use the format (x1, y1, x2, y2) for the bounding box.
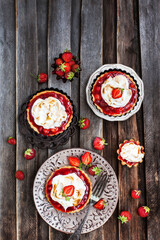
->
(117, 139, 145, 167)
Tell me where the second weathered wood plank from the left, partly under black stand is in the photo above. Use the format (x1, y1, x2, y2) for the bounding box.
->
(16, 0, 38, 240)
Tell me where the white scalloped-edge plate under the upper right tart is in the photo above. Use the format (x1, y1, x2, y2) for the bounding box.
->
(86, 64, 144, 121)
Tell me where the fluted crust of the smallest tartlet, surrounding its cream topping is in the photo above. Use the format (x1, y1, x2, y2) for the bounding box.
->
(117, 139, 145, 168)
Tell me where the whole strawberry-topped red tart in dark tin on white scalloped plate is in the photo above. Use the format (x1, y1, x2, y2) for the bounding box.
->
(92, 70, 138, 116)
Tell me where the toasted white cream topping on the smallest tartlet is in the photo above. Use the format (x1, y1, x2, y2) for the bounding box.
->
(120, 142, 144, 162)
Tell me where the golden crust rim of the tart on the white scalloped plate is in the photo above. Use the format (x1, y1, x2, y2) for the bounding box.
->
(92, 70, 138, 117)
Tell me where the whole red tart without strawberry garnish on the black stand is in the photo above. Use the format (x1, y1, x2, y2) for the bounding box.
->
(27, 90, 73, 136)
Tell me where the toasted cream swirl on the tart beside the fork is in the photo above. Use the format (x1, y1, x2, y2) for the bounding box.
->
(51, 173, 86, 211)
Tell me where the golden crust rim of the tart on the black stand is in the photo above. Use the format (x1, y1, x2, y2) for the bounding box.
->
(26, 90, 73, 136)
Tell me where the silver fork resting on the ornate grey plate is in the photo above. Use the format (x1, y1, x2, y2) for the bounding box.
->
(68, 173, 109, 240)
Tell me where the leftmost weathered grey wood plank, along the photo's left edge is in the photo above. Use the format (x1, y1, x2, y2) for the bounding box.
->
(0, 0, 16, 240)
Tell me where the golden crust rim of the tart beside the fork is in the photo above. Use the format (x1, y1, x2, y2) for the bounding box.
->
(45, 166, 92, 213)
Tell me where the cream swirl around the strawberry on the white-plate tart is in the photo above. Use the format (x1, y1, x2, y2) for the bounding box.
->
(101, 75, 132, 108)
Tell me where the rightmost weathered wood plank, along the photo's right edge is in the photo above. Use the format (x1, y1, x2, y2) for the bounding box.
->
(139, 0, 160, 240)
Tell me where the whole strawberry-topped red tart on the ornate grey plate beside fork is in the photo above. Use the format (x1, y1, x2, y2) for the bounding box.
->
(45, 166, 92, 213)
